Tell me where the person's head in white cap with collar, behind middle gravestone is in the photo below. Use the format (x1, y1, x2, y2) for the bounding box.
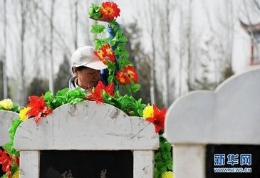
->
(69, 46, 107, 92)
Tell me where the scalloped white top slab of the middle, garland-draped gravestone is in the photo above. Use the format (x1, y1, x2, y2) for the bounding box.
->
(14, 101, 159, 150)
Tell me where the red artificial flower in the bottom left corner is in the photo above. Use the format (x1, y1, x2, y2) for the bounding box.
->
(0, 149, 13, 178)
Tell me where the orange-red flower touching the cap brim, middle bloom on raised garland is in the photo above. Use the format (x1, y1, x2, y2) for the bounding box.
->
(94, 44, 115, 64)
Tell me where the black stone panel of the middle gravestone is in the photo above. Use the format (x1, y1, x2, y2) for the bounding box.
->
(40, 150, 133, 178)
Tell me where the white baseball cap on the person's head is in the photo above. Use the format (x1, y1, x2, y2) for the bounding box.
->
(71, 46, 107, 70)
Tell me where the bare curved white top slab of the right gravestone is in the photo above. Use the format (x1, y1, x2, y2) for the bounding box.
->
(165, 68, 260, 144)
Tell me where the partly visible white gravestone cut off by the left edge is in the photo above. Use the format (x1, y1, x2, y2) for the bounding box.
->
(0, 110, 19, 177)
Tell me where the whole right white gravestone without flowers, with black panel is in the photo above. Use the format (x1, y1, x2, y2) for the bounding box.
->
(165, 68, 260, 178)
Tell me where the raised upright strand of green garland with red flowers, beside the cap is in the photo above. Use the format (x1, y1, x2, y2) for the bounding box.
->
(88, 2, 140, 95)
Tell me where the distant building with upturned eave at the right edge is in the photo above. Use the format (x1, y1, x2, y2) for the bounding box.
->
(240, 21, 260, 66)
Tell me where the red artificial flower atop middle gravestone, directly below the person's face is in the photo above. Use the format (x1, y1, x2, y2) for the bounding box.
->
(87, 81, 115, 102)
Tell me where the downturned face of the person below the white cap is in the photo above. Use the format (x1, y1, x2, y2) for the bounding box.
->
(73, 67, 100, 89)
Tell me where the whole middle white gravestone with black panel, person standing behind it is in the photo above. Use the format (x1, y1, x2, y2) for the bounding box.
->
(14, 101, 159, 178)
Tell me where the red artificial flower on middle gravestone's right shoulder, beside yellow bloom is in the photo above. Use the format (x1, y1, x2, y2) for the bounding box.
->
(146, 105, 166, 133)
